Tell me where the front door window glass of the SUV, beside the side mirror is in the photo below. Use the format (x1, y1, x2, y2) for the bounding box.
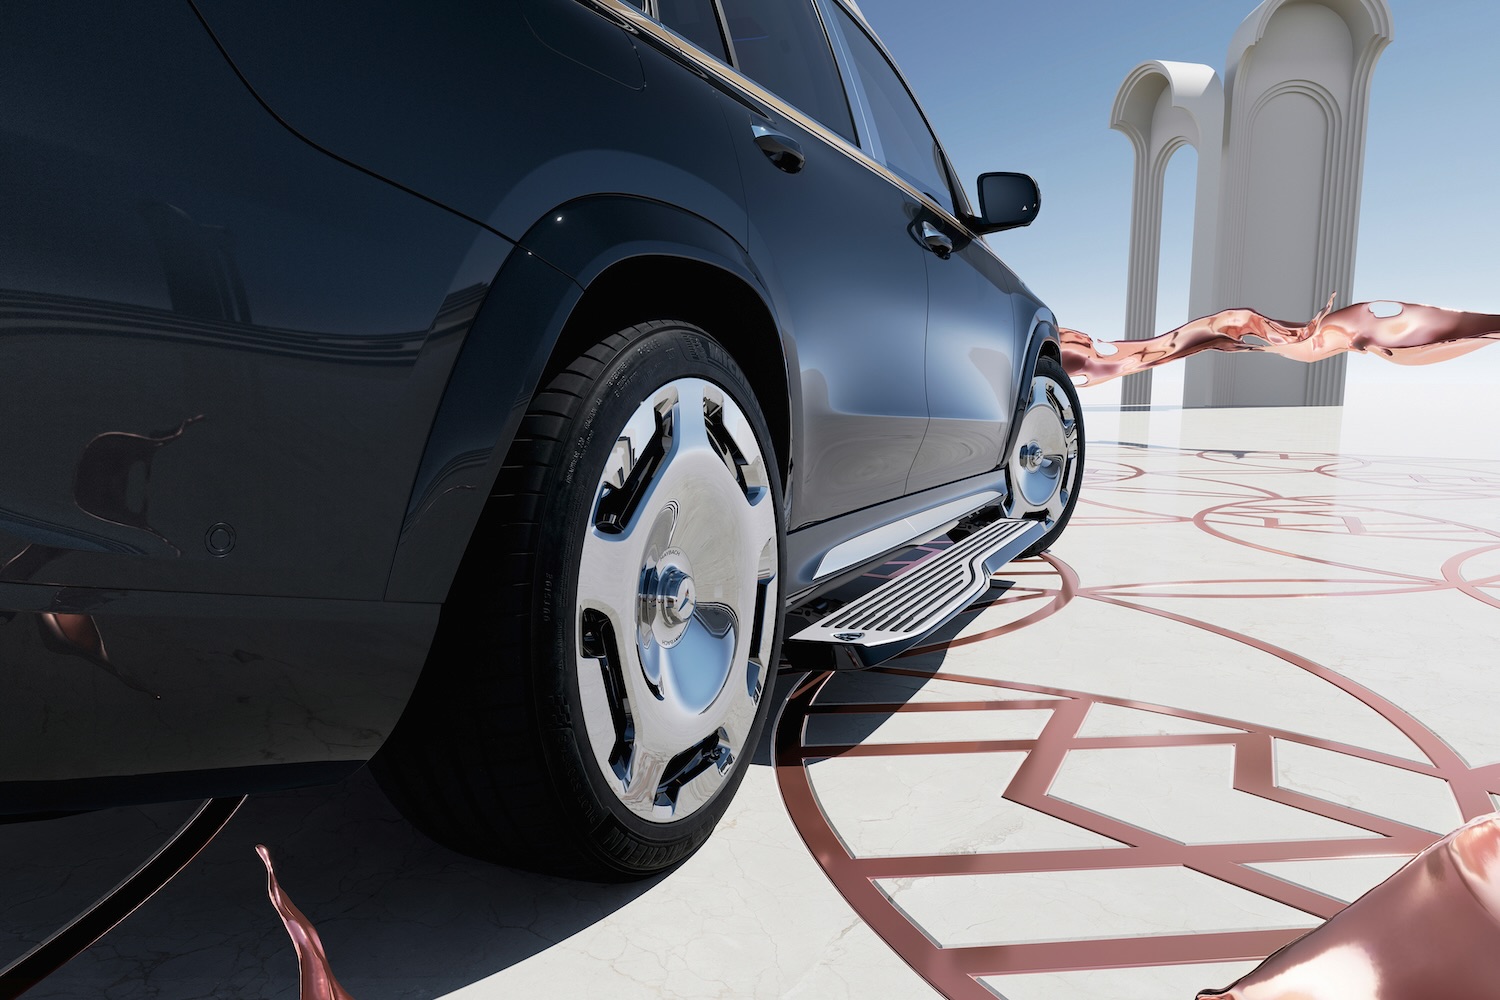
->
(836, 4, 954, 211)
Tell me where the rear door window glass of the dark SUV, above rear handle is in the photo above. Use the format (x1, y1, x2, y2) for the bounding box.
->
(722, 0, 855, 142)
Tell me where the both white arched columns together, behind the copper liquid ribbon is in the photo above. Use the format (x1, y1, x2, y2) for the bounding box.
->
(1110, 0, 1392, 406)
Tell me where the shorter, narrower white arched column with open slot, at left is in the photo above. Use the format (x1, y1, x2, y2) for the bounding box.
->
(1110, 60, 1224, 406)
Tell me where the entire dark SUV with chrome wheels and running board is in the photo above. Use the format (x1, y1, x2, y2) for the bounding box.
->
(0, 0, 1083, 879)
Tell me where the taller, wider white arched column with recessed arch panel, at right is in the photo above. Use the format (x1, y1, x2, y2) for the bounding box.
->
(1184, 0, 1392, 406)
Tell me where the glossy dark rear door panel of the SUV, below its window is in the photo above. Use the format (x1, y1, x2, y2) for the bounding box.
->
(732, 100, 927, 529)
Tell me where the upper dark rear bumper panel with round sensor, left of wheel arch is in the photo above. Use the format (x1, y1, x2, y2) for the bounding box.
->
(0, 3, 512, 600)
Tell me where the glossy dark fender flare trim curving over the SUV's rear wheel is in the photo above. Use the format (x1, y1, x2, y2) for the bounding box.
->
(386, 195, 800, 601)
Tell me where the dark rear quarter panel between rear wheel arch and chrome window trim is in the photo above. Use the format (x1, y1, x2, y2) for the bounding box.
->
(197, 0, 746, 262)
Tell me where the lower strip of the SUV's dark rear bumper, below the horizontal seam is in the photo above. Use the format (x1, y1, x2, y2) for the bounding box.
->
(0, 583, 438, 811)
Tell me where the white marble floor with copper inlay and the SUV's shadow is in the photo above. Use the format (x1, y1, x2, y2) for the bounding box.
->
(0, 377, 1500, 1000)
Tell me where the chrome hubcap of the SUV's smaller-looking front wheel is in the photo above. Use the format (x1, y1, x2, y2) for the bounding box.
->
(1005, 375, 1079, 523)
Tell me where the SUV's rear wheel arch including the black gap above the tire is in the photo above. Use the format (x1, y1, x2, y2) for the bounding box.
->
(386, 196, 798, 601)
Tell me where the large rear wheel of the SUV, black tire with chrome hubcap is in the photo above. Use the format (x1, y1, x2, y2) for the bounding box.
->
(372, 322, 785, 882)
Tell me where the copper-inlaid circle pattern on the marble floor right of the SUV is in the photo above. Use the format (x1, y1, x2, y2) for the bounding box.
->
(776, 444, 1500, 1000)
